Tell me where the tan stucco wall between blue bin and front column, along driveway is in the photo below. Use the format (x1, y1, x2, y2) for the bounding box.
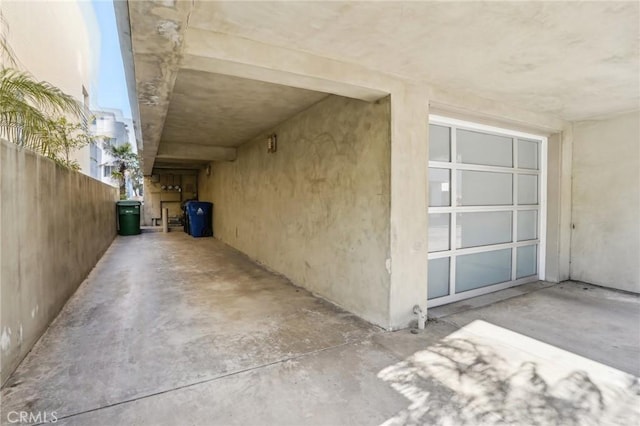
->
(198, 96, 390, 326)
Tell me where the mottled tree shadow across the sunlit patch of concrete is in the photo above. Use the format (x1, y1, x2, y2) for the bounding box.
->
(378, 324, 640, 426)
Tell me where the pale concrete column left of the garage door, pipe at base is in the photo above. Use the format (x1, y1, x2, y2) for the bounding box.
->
(389, 85, 429, 329)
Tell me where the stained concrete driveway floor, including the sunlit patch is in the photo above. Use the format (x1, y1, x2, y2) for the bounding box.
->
(0, 232, 640, 425)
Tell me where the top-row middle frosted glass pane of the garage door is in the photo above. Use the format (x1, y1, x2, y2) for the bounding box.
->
(457, 130, 513, 167)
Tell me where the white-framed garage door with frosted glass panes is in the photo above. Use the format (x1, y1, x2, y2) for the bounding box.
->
(428, 116, 547, 306)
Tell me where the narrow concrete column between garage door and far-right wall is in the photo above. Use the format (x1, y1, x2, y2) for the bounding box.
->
(545, 126, 573, 282)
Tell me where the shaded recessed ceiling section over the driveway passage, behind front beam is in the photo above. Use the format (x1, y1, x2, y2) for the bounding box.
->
(160, 69, 327, 147)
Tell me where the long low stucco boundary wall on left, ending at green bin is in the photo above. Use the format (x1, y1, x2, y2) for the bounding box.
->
(0, 141, 118, 383)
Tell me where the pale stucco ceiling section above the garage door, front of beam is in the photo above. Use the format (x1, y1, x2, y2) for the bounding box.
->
(189, 1, 640, 121)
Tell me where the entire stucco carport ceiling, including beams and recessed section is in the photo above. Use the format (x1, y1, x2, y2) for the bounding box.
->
(122, 0, 640, 174)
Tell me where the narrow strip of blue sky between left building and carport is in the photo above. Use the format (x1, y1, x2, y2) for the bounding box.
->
(91, 0, 131, 118)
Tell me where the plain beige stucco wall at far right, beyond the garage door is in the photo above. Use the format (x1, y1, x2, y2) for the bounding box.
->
(571, 112, 640, 293)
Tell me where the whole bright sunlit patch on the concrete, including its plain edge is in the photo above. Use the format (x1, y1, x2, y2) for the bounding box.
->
(378, 321, 640, 426)
